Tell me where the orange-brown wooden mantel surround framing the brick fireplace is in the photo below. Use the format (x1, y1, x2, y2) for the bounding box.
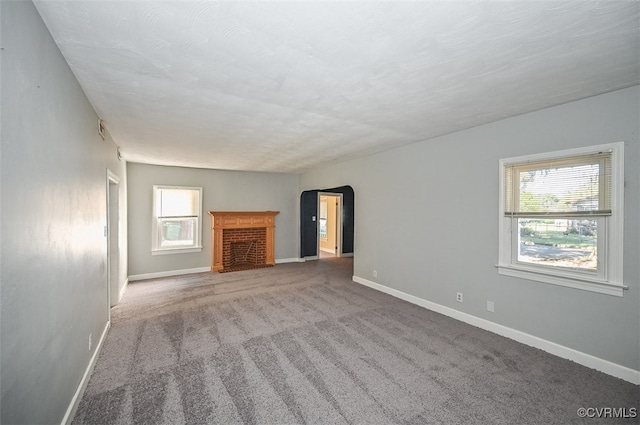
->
(209, 211, 280, 272)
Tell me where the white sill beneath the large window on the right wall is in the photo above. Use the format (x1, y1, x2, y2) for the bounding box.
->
(496, 264, 628, 297)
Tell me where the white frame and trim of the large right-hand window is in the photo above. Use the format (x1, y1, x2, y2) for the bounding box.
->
(496, 142, 628, 297)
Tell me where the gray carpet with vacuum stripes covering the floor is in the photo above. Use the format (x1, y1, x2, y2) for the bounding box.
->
(74, 258, 639, 424)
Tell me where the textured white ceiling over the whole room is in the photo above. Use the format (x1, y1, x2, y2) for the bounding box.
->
(36, 1, 640, 173)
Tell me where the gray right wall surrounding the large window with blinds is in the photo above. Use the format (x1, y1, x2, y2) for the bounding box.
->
(300, 87, 640, 370)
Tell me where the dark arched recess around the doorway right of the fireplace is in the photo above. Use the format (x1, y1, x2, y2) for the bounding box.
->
(300, 186, 355, 258)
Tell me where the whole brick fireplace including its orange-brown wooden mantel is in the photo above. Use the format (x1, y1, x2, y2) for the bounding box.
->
(209, 211, 278, 273)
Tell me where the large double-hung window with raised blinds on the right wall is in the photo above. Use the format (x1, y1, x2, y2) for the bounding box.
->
(498, 143, 625, 296)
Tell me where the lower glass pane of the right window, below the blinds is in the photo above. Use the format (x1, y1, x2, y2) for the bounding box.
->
(518, 218, 598, 272)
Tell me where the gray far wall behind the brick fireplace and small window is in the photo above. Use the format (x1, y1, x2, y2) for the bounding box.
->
(127, 163, 299, 276)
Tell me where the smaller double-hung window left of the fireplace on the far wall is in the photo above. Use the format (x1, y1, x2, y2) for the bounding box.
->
(151, 186, 202, 255)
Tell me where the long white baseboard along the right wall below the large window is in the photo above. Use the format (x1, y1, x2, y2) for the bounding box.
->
(352, 275, 640, 385)
